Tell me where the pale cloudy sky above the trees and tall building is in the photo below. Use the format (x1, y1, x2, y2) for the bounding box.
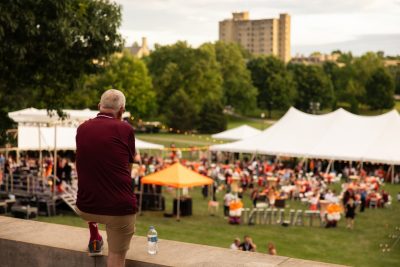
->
(115, 0, 400, 56)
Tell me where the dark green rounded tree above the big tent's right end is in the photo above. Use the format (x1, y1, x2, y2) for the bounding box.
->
(365, 68, 394, 110)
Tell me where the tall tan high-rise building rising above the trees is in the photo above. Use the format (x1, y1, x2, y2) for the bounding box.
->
(219, 12, 290, 62)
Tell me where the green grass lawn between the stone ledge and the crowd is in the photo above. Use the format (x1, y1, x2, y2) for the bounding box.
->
(39, 185, 400, 267)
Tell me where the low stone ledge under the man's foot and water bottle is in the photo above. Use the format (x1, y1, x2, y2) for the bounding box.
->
(0, 216, 346, 267)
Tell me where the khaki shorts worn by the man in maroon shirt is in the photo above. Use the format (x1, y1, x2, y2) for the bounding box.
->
(75, 208, 136, 253)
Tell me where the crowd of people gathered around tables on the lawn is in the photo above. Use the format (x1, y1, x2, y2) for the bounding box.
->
(0, 150, 400, 228)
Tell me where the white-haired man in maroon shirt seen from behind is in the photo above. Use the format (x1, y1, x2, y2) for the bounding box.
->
(76, 89, 136, 267)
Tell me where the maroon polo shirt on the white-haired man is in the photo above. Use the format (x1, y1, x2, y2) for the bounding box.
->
(76, 113, 136, 216)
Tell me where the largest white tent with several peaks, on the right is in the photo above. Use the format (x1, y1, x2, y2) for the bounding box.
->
(210, 108, 400, 165)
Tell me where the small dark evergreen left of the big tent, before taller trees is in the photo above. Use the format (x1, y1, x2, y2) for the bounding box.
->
(198, 101, 227, 133)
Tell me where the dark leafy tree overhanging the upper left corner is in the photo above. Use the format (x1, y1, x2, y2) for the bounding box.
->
(0, 0, 123, 144)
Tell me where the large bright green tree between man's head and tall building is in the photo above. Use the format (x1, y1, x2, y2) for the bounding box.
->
(146, 42, 223, 129)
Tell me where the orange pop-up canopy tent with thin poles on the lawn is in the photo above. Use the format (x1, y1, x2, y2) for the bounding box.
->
(139, 163, 213, 220)
